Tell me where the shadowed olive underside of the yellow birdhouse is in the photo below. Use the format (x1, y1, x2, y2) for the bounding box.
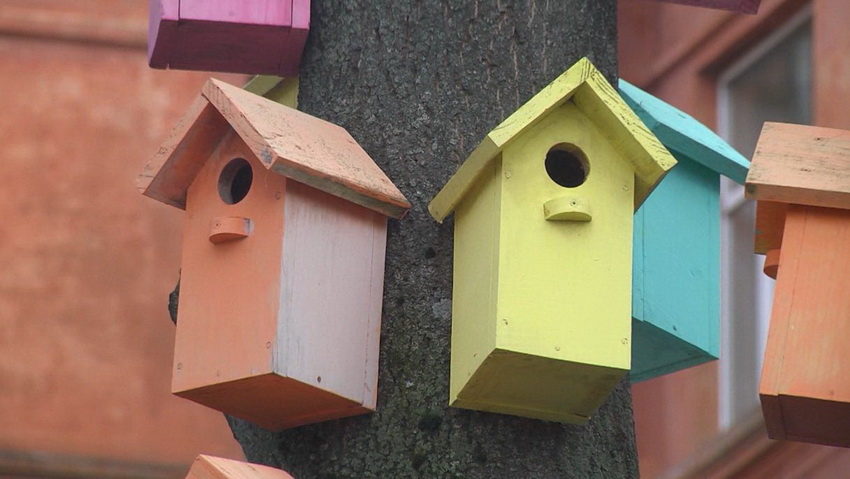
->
(451, 350, 626, 424)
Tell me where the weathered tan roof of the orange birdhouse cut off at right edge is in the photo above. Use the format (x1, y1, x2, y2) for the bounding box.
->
(746, 122, 850, 209)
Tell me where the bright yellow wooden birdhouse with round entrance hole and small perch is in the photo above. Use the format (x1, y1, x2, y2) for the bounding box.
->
(429, 58, 675, 423)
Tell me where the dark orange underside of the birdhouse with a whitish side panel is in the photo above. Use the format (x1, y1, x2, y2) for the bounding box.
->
(175, 373, 372, 430)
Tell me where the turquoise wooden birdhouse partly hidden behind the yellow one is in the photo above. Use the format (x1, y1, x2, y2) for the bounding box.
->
(620, 80, 749, 381)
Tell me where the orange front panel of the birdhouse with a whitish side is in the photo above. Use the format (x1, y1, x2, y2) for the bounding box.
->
(172, 132, 286, 392)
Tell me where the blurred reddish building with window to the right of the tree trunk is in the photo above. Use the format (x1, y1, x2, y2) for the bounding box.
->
(618, 0, 850, 478)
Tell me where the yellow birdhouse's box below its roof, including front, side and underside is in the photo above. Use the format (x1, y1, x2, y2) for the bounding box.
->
(450, 102, 634, 424)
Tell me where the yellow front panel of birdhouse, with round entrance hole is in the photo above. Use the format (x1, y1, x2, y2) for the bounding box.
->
(497, 102, 635, 374)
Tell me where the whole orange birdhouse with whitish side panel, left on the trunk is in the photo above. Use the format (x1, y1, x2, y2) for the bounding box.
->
(139, 80, 409, 429)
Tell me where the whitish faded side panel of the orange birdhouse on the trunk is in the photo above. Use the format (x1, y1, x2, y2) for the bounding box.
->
(275, 181, 387, 409)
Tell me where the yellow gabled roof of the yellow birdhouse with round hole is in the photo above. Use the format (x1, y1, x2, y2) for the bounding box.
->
(428, 58, 676, 221)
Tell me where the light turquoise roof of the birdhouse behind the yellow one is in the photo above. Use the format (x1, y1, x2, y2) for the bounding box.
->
(620, 79, 750, 184)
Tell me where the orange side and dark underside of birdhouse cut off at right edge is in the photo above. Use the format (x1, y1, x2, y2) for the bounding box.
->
(759, 205, 850, 447)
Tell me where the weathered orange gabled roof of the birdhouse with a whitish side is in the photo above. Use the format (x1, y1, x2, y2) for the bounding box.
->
(137, 79, 410, 218)
